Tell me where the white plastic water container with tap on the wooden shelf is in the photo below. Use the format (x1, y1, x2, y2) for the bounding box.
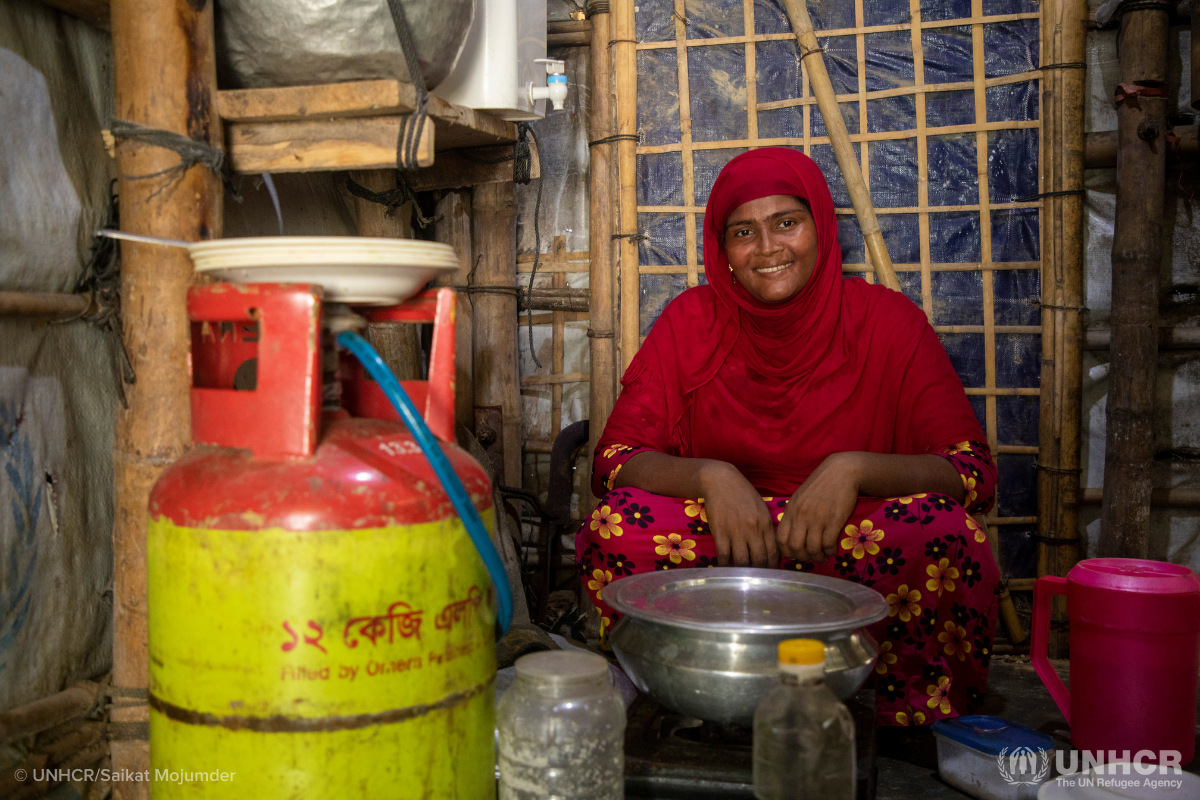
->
(433, 0, 546, 121)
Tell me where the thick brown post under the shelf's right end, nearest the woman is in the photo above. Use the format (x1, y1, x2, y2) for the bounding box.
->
(472, 184, 521, 486)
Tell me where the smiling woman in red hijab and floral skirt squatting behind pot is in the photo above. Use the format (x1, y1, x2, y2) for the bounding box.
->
(576, 148, 998, 726)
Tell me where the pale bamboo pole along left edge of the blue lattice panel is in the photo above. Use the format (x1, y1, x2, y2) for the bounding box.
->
(614, 0, 641, 371)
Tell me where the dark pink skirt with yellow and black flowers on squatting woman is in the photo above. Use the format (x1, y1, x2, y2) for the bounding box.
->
(575, 488, 998, 726)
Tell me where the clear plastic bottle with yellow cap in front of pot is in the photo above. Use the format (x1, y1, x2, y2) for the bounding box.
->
(754, 639, 856, 800)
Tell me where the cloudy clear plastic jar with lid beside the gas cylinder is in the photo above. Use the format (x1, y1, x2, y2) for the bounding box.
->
(496, 650, 625, 800)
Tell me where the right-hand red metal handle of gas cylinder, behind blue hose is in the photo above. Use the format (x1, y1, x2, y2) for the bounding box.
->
(357, 288, 456, 441)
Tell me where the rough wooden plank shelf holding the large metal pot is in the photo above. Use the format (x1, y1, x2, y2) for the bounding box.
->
(217, 80, 516, 175)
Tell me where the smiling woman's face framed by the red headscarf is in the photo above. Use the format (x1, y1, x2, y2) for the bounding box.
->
(725, 194, 817, 302)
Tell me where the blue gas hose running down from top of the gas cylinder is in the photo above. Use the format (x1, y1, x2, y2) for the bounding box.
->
(337, 331, 512, 638)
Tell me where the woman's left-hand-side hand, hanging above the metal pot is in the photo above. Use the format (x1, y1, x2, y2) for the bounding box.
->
(700, 462, 777, 567)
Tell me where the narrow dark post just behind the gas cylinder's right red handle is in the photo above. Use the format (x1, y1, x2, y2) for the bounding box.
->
(433, 190, 475, 434)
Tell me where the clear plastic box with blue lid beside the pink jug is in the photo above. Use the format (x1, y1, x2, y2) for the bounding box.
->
(934, 715, 1055, 800)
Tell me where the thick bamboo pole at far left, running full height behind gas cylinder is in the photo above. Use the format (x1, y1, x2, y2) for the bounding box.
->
(112, 0, 223, 800)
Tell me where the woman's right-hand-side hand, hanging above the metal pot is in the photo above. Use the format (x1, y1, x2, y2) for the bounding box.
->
(775, 452, 860, 561)
